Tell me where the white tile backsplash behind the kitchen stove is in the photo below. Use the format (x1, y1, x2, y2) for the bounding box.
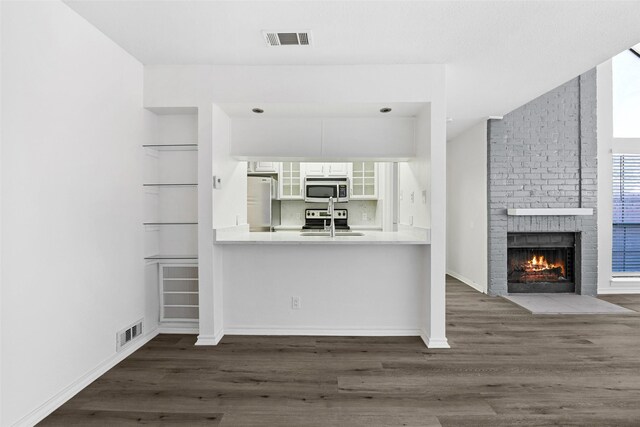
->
(280, 200, 381, 227)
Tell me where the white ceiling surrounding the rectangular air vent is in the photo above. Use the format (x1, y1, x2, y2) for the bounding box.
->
(65, 0, 640, 136)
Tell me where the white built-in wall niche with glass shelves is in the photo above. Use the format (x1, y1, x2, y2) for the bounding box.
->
(142, 108, 198, 330)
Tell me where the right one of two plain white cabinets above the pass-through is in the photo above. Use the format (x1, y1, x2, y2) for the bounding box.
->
(322, 117, 415, 160)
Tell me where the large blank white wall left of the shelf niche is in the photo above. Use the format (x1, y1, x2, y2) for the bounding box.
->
(0, 2, 150, 425)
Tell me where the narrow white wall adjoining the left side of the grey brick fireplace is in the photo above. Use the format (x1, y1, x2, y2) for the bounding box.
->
(447, 120, 488, 293)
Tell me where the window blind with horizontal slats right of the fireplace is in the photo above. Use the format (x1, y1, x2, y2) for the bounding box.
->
(612, 154, 640, 273)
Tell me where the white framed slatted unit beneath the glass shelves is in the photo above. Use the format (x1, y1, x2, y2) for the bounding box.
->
(159, 263, 199, 323)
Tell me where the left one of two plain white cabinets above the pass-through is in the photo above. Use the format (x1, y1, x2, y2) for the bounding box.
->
(230, 118, 322, 158)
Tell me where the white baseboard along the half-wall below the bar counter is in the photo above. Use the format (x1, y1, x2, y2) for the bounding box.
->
(224, 327, 421, 337)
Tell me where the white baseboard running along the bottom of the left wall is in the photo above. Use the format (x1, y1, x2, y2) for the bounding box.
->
(14, 329, 159, 426)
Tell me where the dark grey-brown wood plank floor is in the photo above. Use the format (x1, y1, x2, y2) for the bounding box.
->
(42, 279, 640, 427)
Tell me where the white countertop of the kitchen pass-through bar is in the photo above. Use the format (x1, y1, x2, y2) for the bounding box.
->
(214, 226, 431, 245)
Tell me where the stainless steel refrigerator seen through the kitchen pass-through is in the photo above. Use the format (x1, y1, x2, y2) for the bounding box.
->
(247, 176, 280, 231)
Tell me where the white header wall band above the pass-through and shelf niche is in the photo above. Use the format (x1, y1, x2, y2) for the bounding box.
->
(144, 64, 444, 107)
